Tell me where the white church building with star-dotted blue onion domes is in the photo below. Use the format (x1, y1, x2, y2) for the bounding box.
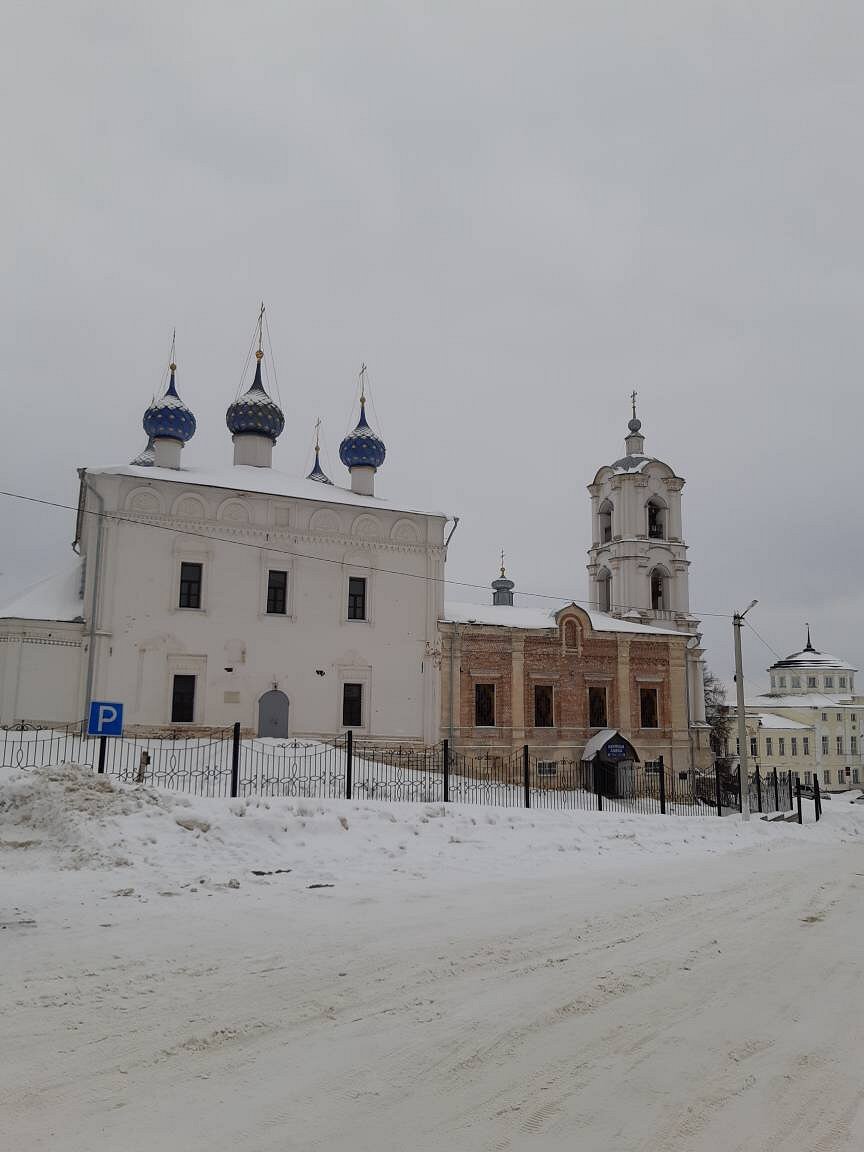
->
(0, 341, 448, 743)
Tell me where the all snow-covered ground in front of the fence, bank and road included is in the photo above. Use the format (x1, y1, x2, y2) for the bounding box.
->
(0, 768, 864, 1152)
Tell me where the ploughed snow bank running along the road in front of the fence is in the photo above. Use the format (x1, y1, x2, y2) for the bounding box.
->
(0, 765, 864, 882)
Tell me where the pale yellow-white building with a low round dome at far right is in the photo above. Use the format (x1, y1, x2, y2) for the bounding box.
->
(729, 628, 864, 791)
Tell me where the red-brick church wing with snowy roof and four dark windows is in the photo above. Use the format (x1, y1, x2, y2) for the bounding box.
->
(439, 594, 710, 771)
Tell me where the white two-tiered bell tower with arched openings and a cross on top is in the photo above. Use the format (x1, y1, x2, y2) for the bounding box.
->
(588, 392, 705, 723)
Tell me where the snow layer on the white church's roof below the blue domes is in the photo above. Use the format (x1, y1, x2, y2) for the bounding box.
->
(88, 464, 452, 520)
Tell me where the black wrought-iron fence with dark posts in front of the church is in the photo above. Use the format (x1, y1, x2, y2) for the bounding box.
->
(0, 723, 819, 816)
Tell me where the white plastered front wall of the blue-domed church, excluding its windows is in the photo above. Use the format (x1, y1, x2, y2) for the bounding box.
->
(81, 477, 444, 742)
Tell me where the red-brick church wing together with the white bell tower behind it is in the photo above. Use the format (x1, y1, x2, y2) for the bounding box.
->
(441, 411, 712, 771)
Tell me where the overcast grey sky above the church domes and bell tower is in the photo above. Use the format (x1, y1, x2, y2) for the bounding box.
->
(0, 0, 864, 680)
